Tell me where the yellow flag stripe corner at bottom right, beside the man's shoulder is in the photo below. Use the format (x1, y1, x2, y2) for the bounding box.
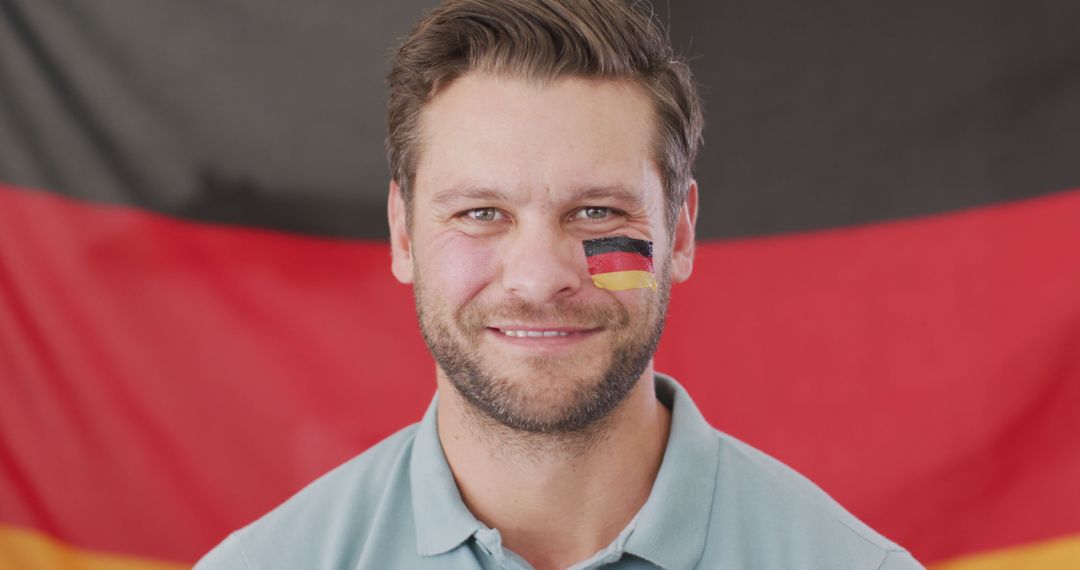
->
(929, 534, 1080, 570)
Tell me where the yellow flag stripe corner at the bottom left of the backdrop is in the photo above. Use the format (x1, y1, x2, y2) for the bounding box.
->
(0, 525, 191, 570)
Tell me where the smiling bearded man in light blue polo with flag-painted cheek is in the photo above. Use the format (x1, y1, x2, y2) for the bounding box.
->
(199, 0, 919, 570)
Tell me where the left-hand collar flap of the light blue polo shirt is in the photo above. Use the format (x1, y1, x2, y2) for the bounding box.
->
(409, 395, 484, 556)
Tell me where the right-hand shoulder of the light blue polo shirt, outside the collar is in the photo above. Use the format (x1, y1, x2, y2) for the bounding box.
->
(704, 430, 922, 570)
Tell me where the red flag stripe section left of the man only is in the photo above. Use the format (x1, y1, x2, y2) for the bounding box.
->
(0, 183, 434, 561)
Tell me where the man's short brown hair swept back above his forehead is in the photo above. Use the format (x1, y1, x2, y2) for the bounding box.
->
(387, 0, 704, 230)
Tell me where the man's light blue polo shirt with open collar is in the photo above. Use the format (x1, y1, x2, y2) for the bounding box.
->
(195, 375, 922, 570)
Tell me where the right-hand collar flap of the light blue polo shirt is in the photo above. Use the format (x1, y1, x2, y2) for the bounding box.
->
(625, 374, 719, 570)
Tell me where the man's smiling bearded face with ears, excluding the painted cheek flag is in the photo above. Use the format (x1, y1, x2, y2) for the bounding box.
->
(390, 74, 692, 433)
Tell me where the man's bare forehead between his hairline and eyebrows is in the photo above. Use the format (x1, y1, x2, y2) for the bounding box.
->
(414, 76, 659, 202)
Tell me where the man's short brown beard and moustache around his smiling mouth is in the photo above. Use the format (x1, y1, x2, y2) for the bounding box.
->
(415, 263, 671, 435)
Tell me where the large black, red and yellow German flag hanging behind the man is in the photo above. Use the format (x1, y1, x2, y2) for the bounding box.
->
(0, 0, 1080, 570)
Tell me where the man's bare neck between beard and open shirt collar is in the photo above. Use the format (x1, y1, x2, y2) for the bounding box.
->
(437, 366, 671, 569)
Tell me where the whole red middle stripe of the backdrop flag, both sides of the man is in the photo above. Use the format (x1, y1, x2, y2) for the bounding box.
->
(0, 187, 1080, 561)
